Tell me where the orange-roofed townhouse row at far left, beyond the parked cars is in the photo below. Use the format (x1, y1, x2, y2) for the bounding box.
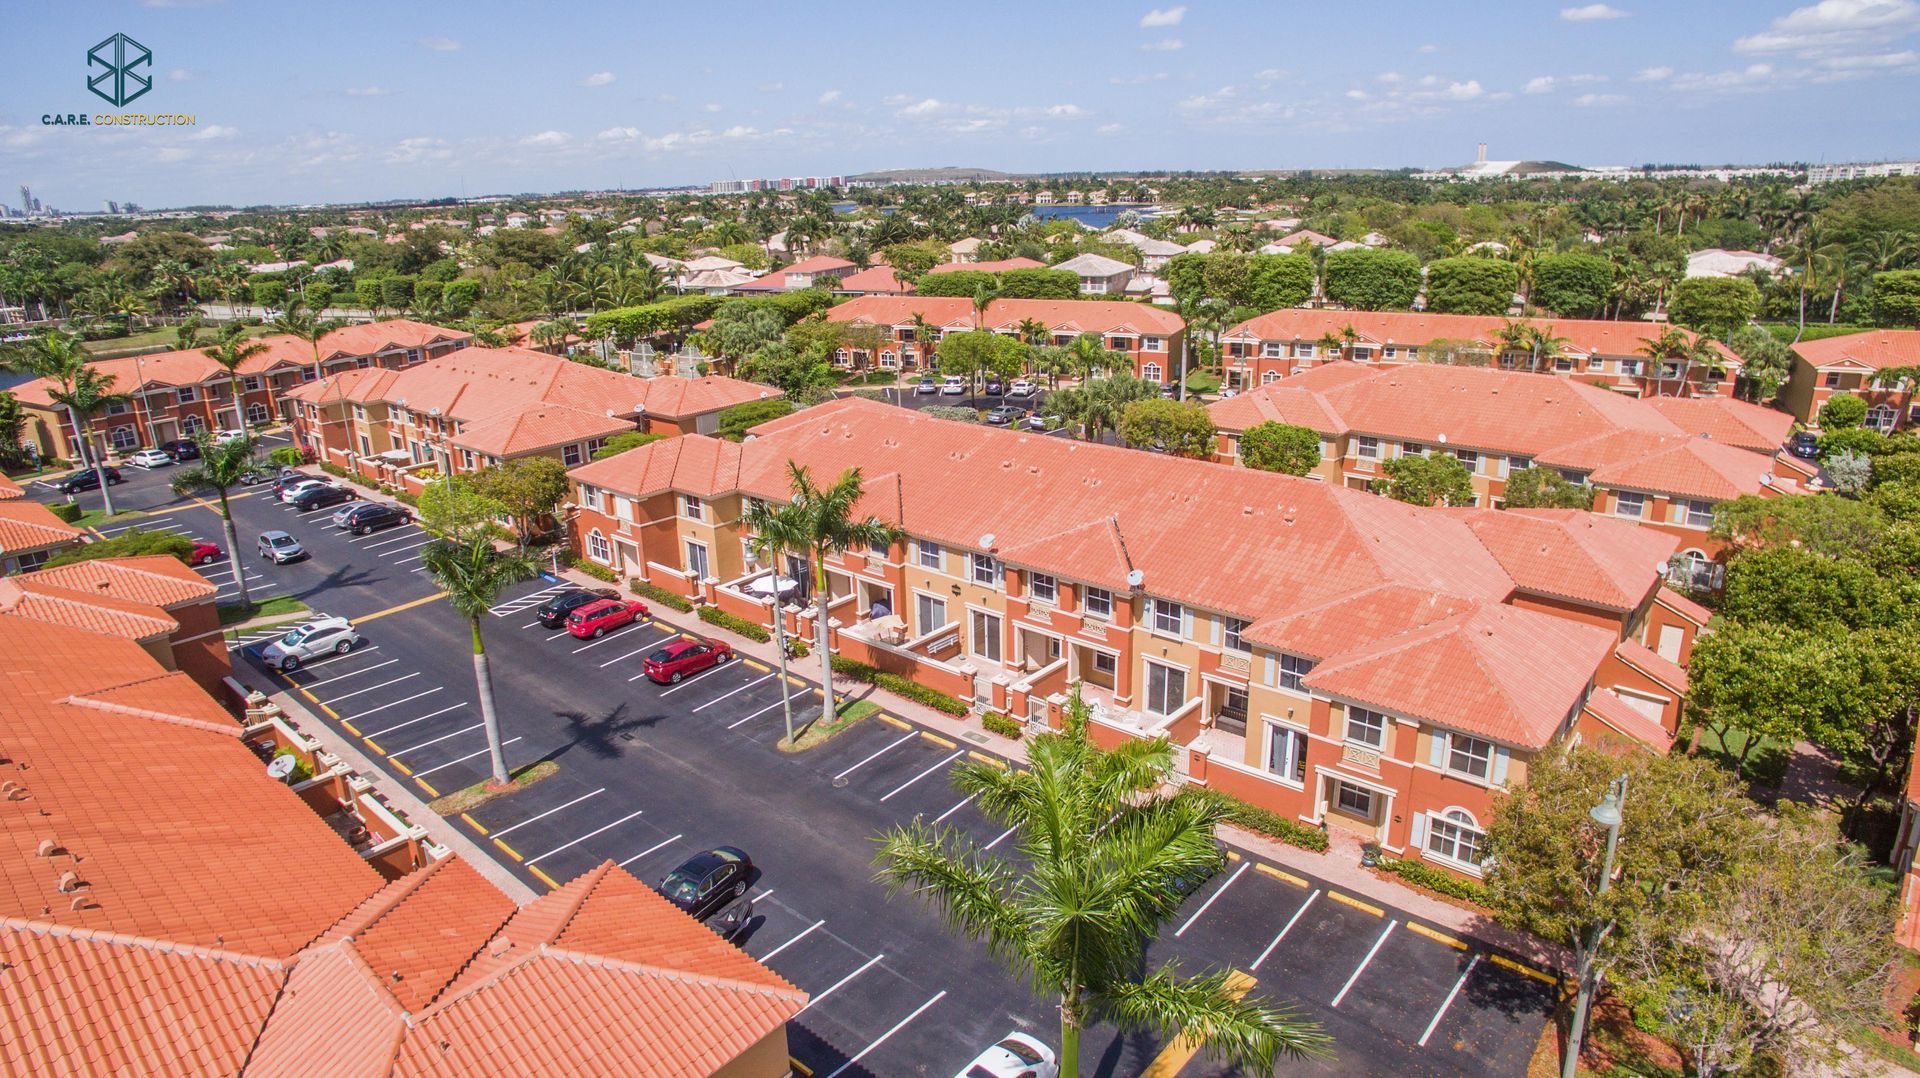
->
(13, 319, 472, 459)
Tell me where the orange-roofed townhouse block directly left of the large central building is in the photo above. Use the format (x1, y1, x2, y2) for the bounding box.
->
(286, 348, 781, 492)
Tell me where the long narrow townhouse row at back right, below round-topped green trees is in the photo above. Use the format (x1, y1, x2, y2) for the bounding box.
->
(1221, 307, 1740, 396)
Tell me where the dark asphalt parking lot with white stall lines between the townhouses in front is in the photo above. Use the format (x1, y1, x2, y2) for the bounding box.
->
(30, 451, 1551, 1076)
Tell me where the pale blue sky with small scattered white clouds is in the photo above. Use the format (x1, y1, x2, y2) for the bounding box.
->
(11, 0, 1920, 209)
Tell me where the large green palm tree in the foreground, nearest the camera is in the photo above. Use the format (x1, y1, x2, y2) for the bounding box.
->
(874, 690, 1329, 1078)
